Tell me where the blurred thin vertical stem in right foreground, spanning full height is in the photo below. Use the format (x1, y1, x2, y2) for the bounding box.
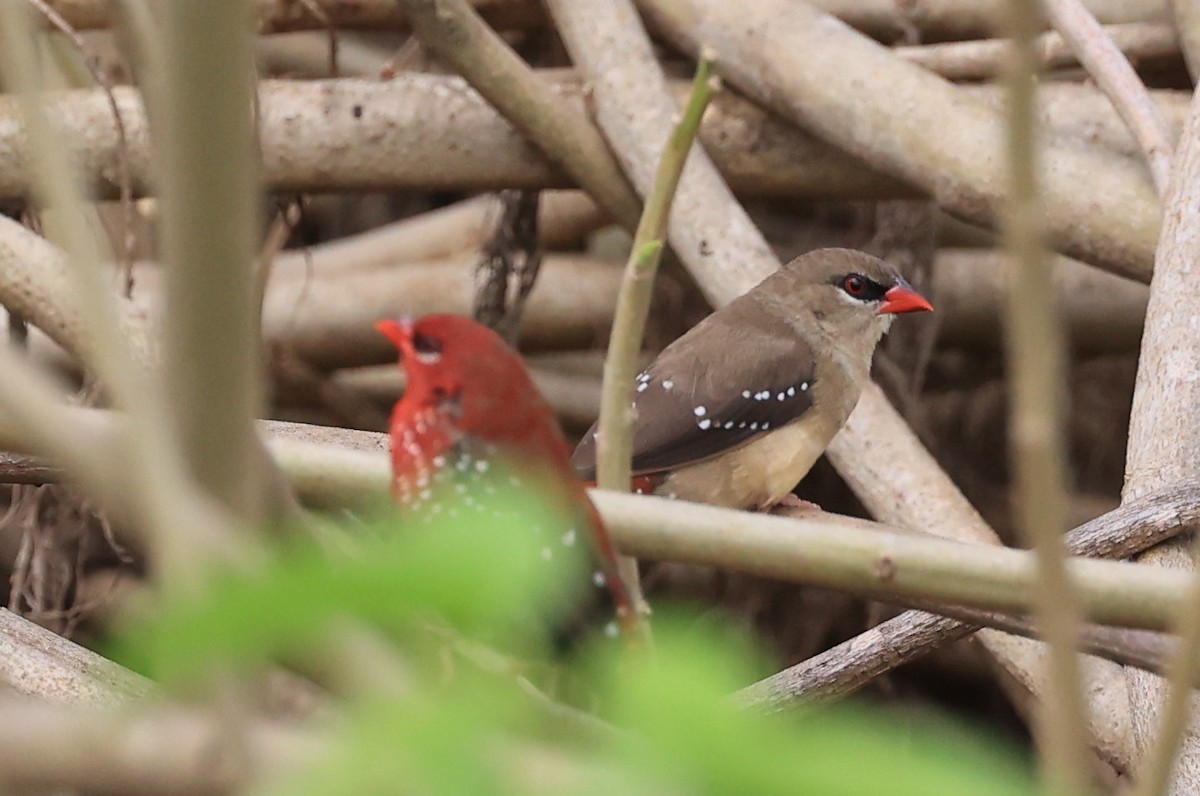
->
(1002, 0, 1088, 796)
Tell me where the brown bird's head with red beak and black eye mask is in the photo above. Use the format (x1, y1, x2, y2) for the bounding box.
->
(773, 249, 934, 346)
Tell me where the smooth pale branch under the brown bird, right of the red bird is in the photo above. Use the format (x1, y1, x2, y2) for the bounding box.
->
(596, 490, 1188, 630)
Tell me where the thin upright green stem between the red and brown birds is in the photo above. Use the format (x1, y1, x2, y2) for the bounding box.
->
(596, 53, 715, 629)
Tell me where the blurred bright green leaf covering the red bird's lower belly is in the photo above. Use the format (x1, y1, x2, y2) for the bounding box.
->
(113, 471, 587, 682)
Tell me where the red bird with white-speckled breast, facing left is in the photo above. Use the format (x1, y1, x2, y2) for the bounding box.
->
(376, 315, 637, 632)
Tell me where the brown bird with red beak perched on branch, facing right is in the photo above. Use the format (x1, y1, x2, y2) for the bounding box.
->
(571, 249, 932, 509)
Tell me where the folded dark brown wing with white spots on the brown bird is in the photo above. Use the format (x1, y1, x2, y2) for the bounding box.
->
(571, 303, 815, 480)
